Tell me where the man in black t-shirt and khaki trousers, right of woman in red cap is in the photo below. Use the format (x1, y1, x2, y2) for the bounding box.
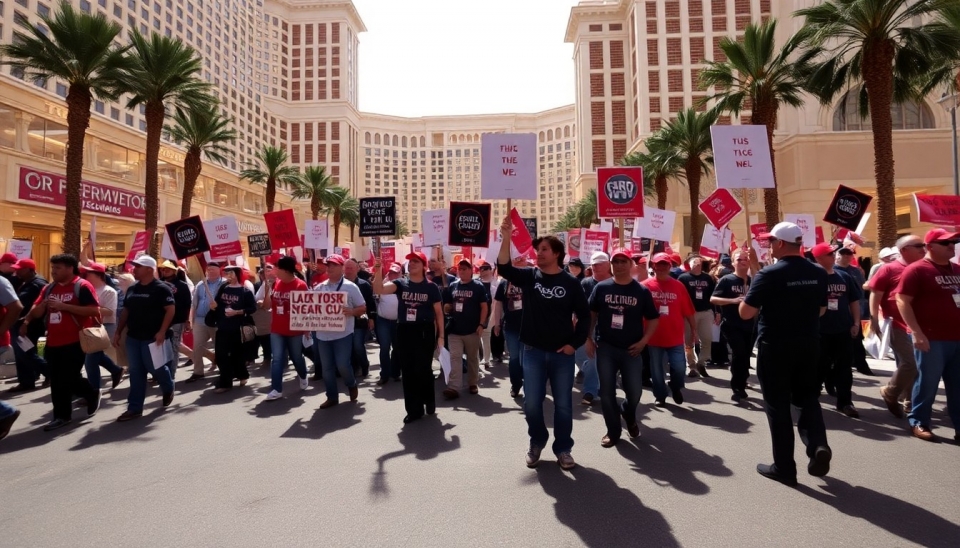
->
(443, 259, 490, 400)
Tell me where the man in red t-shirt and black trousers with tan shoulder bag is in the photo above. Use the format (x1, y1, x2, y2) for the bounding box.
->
(20, 254, 100, 432)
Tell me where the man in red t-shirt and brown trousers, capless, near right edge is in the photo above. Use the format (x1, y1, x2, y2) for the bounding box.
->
(867, 234, 926, 419)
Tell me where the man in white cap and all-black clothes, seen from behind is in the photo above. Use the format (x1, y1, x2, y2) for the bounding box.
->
(740, 223, 832, 486)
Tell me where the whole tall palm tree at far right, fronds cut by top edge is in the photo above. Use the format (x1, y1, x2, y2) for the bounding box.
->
(795, 0, 960, 246)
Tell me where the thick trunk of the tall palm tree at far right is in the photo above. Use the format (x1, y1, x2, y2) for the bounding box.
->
(863, 41, 897, 247)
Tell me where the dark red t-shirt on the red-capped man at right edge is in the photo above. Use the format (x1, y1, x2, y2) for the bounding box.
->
(897, 259, 960, 341)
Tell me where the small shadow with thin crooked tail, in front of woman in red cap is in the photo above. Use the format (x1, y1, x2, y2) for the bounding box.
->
(370, 415, 460, 498)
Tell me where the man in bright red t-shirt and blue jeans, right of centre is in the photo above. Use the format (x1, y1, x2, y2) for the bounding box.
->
(643, 253, 699, 407)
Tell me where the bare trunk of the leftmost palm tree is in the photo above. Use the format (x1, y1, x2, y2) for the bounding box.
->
(63, 86, 93, 257)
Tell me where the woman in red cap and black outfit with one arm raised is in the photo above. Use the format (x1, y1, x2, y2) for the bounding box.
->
(373, 252, 443, 423)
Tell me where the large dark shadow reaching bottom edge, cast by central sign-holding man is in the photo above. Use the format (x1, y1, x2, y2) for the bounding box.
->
(537, 463, 680, 548)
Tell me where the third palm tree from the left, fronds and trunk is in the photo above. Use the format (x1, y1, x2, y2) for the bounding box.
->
(164, 98, 237, 219)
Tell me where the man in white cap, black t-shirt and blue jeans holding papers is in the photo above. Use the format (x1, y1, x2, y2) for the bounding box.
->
(113, 255, 176, 422)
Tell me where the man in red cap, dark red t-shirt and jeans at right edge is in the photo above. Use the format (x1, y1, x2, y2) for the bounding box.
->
(897, 228, 960, 441)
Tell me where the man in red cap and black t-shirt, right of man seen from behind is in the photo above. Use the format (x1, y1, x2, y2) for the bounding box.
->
(810, 243, 863, 419)
